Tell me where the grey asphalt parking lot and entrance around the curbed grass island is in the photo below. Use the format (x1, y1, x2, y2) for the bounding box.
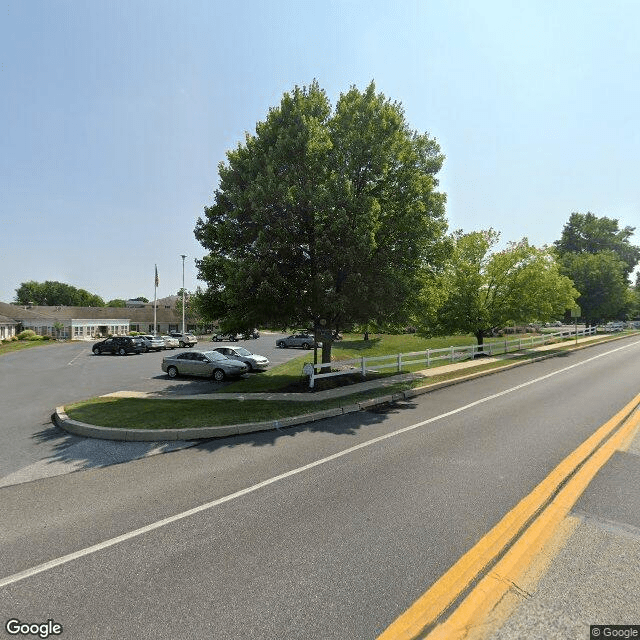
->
(0, 333, 304, 486)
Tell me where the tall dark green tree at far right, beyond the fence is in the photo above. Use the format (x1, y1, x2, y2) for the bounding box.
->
(554, 213, 640, 325)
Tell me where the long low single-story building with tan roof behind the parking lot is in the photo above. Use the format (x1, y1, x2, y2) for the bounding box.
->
(0, 296, 195, 340)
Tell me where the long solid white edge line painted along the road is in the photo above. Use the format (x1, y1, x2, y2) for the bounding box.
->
(0, 341, 640, 588)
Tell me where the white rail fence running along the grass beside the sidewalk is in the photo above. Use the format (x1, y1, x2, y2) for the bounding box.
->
(303, 327, 596, 389)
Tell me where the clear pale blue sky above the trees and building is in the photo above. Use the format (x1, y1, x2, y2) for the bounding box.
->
(0, 0, 640, 302)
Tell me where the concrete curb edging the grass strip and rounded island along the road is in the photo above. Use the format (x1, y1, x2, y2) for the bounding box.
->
(52, 336, 628, 442)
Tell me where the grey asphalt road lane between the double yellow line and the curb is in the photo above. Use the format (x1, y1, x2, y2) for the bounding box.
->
(0, 338, 640, 640)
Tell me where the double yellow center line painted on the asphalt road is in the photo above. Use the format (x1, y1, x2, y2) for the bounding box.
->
(378, 394, 640, 640)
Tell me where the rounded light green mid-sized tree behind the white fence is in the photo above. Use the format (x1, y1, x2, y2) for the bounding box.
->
(417, 229, 578, 345)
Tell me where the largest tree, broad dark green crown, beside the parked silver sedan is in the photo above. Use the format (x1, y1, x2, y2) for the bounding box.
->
(195, 81, 447, 362)
